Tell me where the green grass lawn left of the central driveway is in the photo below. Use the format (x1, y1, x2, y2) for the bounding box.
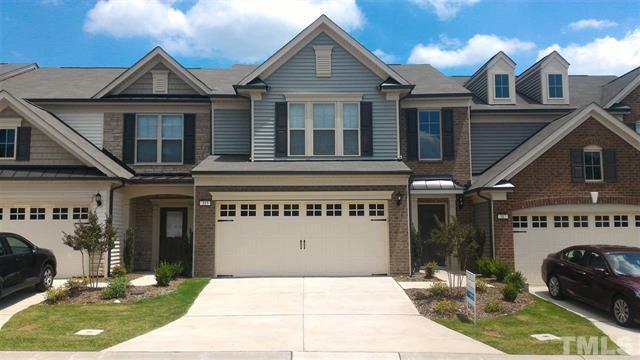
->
(0, 279, 209, 351)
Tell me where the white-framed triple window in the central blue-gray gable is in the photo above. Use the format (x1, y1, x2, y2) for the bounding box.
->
(288, 101, 360, 156)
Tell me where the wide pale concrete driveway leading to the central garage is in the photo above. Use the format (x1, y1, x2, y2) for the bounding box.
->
(108, 277, 499, 355)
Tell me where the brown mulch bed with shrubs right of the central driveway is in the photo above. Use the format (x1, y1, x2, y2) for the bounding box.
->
(405, 281, 533, 319)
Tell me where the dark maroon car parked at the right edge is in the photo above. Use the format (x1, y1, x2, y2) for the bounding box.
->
(542, 245, 640, 326)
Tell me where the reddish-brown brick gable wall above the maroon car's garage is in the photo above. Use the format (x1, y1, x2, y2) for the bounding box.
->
(493, 118, 640, 266)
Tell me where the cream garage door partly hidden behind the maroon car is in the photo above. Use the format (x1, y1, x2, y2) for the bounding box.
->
(512, 205, 640, 284)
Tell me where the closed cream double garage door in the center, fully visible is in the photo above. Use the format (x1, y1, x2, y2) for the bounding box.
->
(215, 200, 389, 276)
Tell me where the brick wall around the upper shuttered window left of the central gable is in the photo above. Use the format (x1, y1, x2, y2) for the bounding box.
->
(103, 112, 211, 173)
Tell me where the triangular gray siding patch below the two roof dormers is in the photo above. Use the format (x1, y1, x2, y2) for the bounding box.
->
(471, 122, 546, 174)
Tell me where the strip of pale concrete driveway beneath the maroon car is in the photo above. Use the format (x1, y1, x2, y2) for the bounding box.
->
(529, 286, 640, 356)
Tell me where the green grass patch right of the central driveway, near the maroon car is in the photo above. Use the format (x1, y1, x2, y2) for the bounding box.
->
(436, 296, 618, 355)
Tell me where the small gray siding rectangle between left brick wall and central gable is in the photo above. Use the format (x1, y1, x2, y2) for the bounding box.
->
(213, 109, 251, 155)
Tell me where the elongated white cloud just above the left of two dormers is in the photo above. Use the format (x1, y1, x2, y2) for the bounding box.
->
(408, 34, 535, 68)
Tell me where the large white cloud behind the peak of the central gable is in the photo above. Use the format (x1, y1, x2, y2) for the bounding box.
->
(84, 0, 365, 62)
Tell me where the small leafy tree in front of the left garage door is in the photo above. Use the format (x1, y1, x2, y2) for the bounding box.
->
(62, 212, 116, 287)
